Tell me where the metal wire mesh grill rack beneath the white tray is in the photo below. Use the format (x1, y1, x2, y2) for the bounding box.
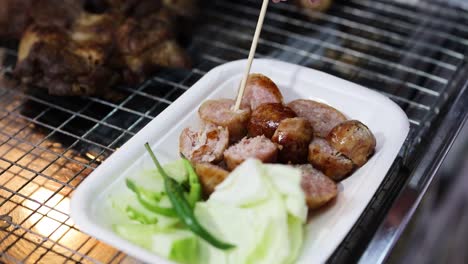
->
(0, 0, 468, 263)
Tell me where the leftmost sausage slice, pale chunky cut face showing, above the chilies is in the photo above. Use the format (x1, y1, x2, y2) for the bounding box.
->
(179, 123, 229, 163)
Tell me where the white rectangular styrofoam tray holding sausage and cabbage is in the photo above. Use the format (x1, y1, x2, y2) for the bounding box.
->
(71, 59, 409, 263)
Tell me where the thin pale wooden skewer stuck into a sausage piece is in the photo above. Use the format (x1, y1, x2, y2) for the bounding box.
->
(234, 0, 270, 111)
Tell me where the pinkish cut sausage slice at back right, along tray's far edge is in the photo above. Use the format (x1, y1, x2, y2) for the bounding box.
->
(288, 99, 346, 138)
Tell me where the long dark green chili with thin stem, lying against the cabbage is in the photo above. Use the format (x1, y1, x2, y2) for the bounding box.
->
(145, 143, 235, 250)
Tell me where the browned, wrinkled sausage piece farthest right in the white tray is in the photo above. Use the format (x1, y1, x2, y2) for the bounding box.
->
(327, 120, 376, 167)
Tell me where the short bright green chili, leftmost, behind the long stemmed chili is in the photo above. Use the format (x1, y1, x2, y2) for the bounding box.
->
(126, 179, 177, 217)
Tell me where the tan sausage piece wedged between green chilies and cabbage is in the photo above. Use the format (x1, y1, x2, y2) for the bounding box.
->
(195, 163, 229, 197)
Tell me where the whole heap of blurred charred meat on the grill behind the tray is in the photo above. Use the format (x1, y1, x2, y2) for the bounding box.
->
(0, 0, 195, 96)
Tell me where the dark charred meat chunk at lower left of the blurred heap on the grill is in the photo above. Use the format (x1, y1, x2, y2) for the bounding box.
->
(15, 22, 117, 95)
